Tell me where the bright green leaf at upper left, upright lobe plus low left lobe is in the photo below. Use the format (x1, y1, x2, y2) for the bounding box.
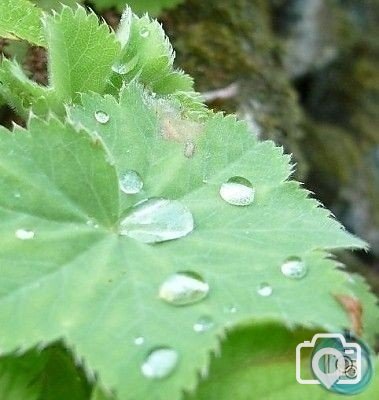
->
(0, 6, 120, 119)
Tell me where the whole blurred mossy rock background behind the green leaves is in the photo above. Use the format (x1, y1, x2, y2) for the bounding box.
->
(0, 0, 379, 294)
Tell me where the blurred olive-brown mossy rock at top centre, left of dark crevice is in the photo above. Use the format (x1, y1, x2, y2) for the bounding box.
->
(164, 0, 306, 176)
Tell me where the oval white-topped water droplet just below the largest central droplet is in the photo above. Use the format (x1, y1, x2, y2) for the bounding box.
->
(159, 271, 209, 306)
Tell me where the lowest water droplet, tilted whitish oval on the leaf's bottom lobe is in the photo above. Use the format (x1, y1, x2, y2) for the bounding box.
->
(141, 347, 179, 379)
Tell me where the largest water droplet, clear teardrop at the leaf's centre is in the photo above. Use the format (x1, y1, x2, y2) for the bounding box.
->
(120, 197, 194, 243)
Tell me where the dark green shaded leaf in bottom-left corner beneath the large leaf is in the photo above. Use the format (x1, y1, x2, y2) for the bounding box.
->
(0, 346, 90, 400)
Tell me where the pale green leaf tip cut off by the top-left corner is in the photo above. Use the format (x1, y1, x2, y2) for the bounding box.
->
(0, 0, 45, 46)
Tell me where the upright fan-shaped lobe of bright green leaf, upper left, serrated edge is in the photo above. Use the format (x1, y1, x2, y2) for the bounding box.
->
(45, 7, 119, 102)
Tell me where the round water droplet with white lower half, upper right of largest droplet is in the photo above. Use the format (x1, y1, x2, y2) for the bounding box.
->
(220, 176, 255, 206)
